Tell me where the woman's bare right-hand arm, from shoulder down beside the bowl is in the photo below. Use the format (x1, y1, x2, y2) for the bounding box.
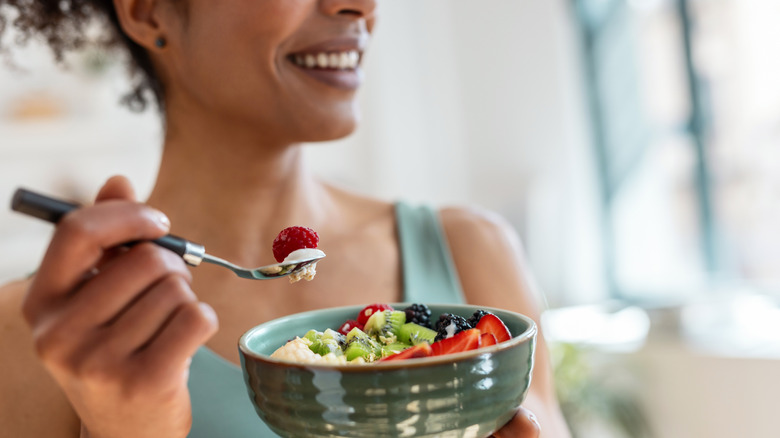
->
(441, 208, 570, 438)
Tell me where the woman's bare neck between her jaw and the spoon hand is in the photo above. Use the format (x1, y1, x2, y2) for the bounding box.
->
(148, 109, 334, 266)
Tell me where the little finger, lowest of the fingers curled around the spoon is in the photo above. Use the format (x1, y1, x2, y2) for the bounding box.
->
(138, 302, 218, 381)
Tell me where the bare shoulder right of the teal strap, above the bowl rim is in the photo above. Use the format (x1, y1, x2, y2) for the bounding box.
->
(440, 207, 540, 317)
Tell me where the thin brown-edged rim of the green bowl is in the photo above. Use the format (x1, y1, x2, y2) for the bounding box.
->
(238, 303, 538, 372)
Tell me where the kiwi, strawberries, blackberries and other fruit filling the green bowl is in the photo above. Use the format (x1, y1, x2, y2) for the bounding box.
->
(275, 304, 512, 363)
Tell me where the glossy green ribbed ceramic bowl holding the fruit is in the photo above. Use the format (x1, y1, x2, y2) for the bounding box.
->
(239, 304, 537, 438)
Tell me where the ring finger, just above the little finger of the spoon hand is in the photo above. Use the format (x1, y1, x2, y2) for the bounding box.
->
(105, 274, 198, 357)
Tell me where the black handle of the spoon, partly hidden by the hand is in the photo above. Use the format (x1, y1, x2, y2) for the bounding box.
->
(11, 189, 205, 266)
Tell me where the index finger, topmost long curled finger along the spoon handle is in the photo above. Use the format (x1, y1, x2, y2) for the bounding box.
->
(23, 201, 170, 319)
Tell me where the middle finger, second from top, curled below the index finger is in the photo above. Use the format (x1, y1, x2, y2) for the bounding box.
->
(58, 242, 192, 327)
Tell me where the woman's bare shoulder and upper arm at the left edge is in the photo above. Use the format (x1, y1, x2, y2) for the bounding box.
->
(0, 281, 80, 438)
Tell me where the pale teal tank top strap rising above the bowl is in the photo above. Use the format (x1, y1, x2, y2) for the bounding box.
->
(395, 202, 465, 304)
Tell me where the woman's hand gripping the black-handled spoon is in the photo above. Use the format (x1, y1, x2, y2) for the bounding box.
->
(3, 178, 217, 438)
